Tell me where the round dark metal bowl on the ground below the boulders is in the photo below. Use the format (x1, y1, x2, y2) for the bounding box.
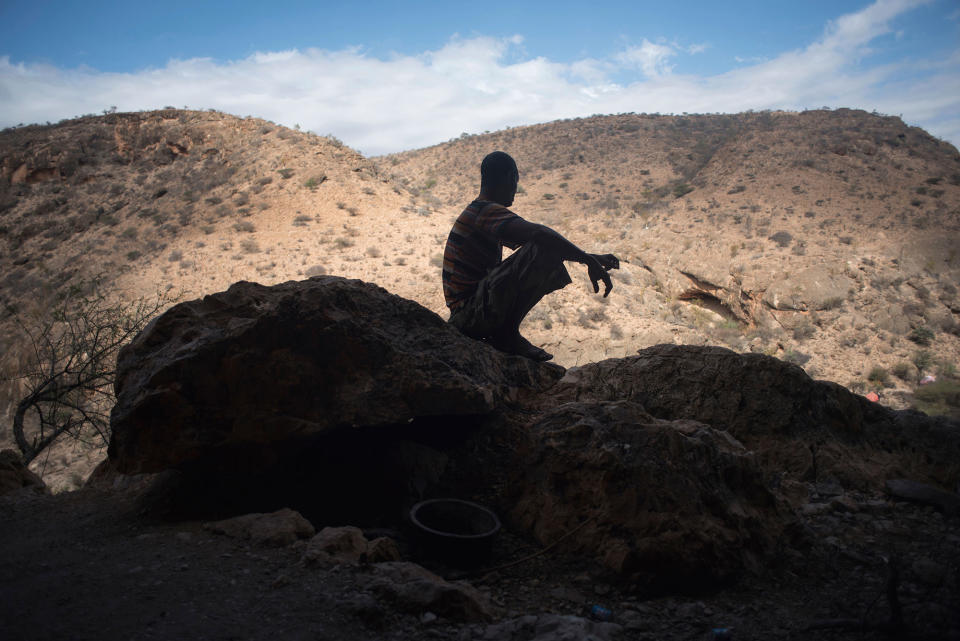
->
(410, 499, 500, 567)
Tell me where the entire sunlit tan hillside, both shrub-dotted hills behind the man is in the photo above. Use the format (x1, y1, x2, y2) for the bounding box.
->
(0, 110, 960, 488)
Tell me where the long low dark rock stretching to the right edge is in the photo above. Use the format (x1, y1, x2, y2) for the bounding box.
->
(541, 345, 960, 488)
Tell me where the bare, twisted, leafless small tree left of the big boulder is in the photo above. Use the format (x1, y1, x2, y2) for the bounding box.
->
(5, 279, 174, 463)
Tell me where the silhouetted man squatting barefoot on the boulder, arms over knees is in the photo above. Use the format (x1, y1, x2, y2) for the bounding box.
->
(443, 151, 620, 361)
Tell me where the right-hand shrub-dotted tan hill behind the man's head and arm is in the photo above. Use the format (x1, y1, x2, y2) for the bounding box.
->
(379, 109, 960, 384)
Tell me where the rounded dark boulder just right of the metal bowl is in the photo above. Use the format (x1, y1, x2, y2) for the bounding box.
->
(511, 400, 792, 589)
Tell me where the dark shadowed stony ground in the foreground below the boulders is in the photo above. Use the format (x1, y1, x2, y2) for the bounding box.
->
(0, 485, 960, 641)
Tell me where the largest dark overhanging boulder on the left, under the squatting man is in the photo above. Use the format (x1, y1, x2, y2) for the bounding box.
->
(109, 276, 563, 474)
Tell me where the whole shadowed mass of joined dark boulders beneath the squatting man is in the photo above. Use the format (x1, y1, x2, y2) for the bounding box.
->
(109, 277, 960, 592)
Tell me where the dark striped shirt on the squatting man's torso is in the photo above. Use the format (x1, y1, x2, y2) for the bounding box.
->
(443, 200, 522, 310)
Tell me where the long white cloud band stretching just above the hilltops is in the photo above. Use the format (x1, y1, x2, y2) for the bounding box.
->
(0, 0, 960, 154)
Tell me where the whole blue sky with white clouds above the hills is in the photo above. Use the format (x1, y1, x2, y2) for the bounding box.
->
(0, 0, 960, 154)
